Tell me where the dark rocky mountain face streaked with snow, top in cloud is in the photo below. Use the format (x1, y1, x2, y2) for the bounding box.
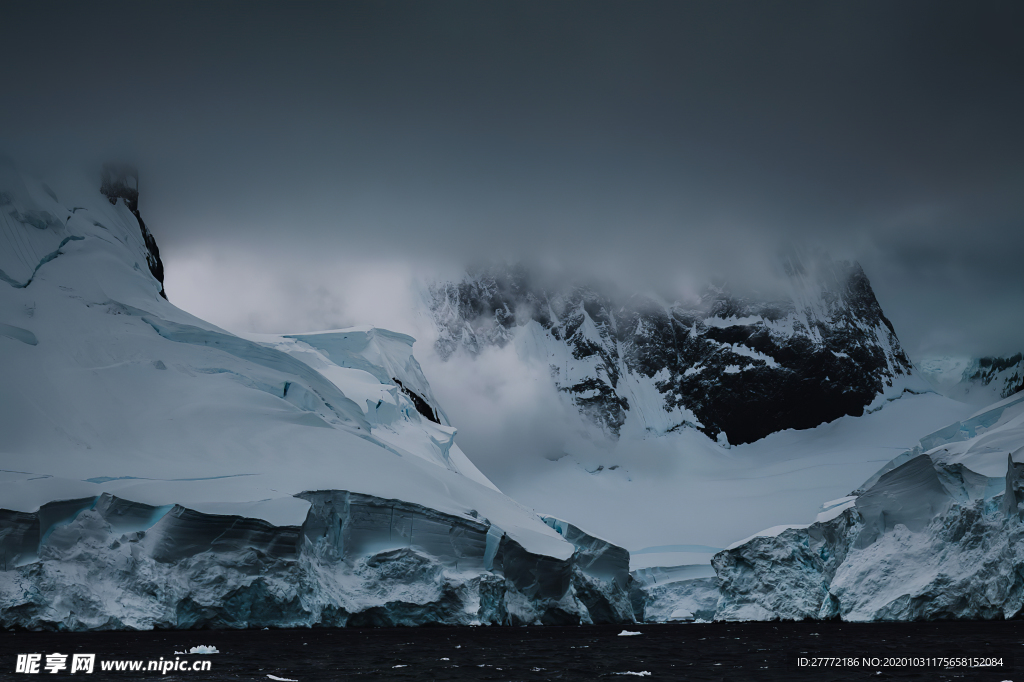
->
(430, 258, 925, 444)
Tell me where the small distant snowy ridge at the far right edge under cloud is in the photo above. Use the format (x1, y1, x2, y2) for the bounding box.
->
(918, 353, 1024, 406)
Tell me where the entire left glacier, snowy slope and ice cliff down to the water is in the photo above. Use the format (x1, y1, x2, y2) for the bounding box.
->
(0, 160, 632, 630)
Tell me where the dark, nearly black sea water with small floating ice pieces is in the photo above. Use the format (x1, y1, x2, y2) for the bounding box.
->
(0, 621, 1024, 682)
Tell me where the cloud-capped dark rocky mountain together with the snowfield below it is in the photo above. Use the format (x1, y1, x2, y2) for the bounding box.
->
(425, 259, 971, 577)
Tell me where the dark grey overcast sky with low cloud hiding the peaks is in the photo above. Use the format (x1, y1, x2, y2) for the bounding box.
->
(0, 0, 1024, 358)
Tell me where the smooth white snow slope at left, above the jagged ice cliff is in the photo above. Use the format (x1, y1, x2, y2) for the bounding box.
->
(0, 164, 572, 559)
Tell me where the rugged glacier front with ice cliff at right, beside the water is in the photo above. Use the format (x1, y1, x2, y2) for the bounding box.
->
(713, 395, 1024, 621)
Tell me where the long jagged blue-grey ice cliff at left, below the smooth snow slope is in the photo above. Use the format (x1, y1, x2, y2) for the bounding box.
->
(0, 491, 632, 630)
